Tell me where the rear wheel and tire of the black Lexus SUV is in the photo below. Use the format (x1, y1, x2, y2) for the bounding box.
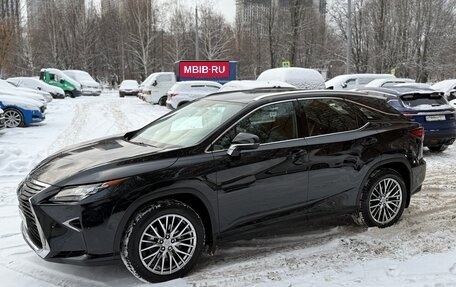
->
(355, 169, 407, 228)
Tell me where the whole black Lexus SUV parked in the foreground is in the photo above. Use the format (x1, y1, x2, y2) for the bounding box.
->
(17, 89, 426, 282)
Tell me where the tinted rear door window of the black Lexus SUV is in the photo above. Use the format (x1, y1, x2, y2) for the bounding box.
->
(300, 99, 363, 136)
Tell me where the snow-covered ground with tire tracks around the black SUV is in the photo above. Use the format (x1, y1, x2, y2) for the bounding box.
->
(0, 93, 456, 287)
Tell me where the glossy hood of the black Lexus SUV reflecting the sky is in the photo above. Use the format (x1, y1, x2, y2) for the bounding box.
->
(30, 136, 177, 186)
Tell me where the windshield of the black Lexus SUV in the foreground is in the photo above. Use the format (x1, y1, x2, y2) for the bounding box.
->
(130, 99, 244, 148)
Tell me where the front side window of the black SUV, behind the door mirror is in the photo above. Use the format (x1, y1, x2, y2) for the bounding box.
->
(214, 102, 298, 150)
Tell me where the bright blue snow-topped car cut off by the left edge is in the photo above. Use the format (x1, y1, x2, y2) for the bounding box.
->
(0, 95, 45, 128)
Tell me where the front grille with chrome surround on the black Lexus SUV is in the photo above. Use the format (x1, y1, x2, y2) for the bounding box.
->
(18, 181, 46, 248)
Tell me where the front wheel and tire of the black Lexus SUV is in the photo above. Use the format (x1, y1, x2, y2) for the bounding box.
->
(121, 200, 205, 283)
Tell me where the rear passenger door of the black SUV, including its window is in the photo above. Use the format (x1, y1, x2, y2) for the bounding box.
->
(299, 98, 370, 209)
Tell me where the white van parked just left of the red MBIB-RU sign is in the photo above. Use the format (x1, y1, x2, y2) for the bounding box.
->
(140, 72, 176, 106)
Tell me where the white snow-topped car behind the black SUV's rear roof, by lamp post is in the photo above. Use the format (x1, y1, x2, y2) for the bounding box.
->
(325, 74, 396, 90)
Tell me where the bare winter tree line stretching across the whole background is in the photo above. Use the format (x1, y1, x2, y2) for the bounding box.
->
(0, 0, 456, 82)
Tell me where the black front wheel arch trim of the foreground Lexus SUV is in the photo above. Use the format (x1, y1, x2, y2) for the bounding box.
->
(114, 189, 218, 253)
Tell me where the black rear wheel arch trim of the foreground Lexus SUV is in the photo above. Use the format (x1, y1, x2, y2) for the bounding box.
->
(356, 157, 412, 208)
